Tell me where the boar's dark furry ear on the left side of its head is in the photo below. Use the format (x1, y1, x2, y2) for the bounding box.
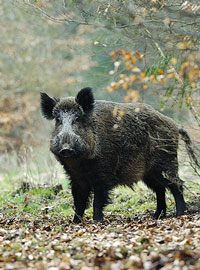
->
(40, 93, 58, 120)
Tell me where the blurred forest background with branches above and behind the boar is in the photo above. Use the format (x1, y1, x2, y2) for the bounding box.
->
(0, 0, 200, 188)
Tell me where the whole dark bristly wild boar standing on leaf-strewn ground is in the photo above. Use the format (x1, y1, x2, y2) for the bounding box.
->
(41, 87, 199, 223)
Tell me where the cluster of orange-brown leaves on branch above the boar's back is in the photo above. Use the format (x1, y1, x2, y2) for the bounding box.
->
(107, 48, 200, 105)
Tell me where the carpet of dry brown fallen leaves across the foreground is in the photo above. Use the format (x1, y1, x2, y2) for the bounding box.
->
(0, 213, 200, 270)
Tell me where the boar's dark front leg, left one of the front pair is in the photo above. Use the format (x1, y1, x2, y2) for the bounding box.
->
(71, 183, 90, 223)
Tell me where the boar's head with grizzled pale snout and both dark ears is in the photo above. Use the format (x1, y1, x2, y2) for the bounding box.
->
(41, 88, 95, 158)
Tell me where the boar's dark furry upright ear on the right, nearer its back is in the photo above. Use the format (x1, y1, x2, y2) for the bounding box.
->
(75, 87, 94, 113)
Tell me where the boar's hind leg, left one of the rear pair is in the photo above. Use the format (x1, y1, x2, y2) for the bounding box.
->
(144, 175, 166, 219)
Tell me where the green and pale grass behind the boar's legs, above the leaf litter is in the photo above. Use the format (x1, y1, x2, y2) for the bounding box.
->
(0, 146, 200, 223)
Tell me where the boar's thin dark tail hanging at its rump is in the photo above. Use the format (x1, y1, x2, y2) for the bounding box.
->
(179, 128, 200, 175)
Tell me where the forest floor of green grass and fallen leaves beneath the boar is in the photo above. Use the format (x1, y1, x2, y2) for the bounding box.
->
(0, 180, 200, 270)
